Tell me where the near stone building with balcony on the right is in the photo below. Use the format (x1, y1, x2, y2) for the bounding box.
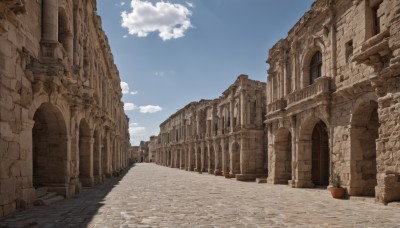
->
(266, 0, 400, 203)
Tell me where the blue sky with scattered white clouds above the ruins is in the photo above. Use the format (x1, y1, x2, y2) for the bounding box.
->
(97, 0, 313, 145)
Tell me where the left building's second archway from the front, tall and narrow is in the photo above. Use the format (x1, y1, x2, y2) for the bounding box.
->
(78, 119, 93, 187)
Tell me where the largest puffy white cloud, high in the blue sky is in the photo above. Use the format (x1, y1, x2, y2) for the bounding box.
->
(121, 0, 192, 41)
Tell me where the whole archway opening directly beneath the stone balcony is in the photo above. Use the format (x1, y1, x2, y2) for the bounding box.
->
(297, 116, 330, 187)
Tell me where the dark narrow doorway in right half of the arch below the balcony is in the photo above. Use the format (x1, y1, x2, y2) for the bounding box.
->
(311, 120, 329, 186)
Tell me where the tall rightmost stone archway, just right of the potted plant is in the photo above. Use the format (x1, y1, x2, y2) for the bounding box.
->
(349, 100, 380, 196)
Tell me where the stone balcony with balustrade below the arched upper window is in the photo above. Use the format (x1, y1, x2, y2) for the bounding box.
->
(288, 76, 331, 108)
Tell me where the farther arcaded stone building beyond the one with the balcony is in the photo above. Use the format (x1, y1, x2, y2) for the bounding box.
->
(156, 75, 266, 180)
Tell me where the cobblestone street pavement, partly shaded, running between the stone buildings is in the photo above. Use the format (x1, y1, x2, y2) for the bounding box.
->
(0, 163, 400, 227)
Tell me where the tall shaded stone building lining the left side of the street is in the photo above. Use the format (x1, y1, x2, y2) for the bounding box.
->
(0, 0, 130, 216)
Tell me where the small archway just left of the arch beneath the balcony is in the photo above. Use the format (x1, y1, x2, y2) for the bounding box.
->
(274, 128, 292, 184)
